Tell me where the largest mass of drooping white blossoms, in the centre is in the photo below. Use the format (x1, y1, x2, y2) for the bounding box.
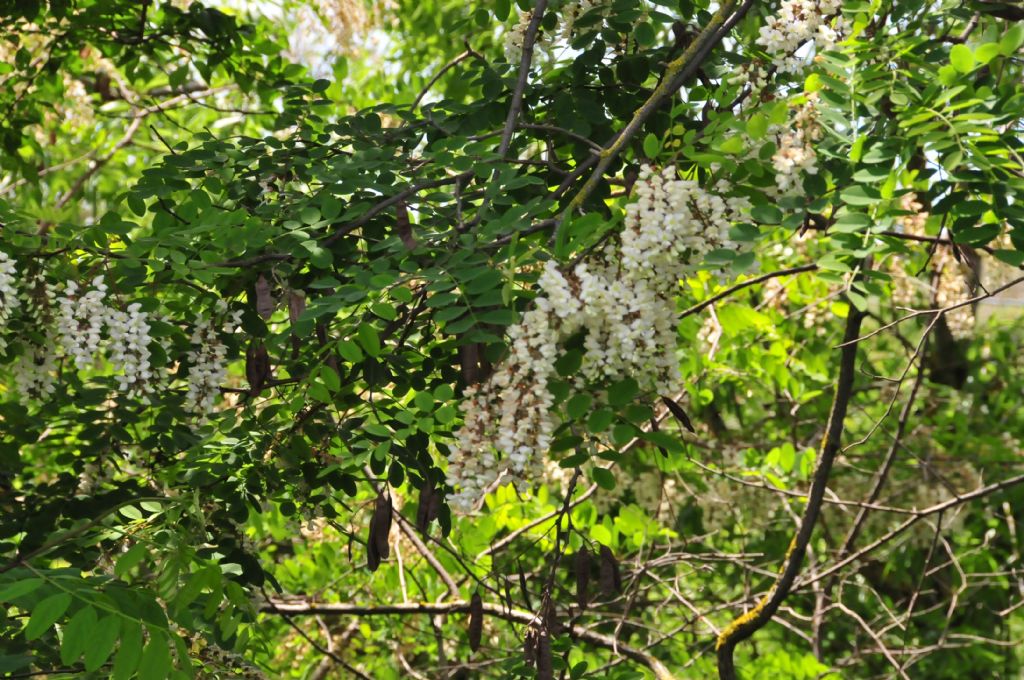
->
(447, 166, 750, 511)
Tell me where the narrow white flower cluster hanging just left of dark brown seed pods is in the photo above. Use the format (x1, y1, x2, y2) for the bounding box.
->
(185, 300, 242, 423)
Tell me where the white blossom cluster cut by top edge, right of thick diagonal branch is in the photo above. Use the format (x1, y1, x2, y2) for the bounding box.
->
(757, 0, 847, 74)
